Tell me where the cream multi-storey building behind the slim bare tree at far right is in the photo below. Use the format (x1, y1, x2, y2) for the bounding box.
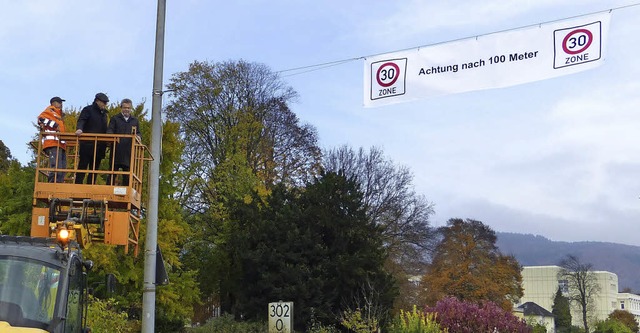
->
(520, 266, 640, 327)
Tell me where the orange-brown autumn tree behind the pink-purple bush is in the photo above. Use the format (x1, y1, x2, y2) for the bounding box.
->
(422, 219, 523, 310)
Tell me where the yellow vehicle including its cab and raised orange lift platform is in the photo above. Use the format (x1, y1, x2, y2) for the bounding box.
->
(0, 133, 151, 333)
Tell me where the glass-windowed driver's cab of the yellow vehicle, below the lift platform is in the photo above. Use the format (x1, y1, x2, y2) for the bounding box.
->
(0, 236, 93, 333)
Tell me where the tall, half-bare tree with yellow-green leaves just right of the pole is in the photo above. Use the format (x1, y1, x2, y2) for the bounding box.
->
(165, 61, 321, 316)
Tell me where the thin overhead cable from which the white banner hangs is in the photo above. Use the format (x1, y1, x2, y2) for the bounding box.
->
(276, 2, 640, 77)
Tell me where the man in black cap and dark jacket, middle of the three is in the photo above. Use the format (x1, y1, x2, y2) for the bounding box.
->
(75, 93, 109, 184)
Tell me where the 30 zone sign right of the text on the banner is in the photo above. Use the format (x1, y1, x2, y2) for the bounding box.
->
(553, 21, 602, 68)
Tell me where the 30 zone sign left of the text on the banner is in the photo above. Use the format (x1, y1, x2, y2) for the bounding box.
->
(371, 58, 407, 100)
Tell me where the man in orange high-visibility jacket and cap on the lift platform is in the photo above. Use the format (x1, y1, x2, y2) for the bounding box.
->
(38, 96, 67, 183)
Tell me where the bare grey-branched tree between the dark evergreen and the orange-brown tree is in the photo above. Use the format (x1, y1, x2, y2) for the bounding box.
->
(323, 146, 435, 309)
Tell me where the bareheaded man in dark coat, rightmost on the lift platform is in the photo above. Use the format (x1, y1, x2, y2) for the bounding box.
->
(107, 98, 140, 186)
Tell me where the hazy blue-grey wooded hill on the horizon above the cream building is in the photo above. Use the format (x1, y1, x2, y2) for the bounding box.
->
(496, 232, 640, 294)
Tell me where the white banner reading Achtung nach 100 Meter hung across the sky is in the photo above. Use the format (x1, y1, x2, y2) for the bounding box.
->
(364, 13, 611, 107)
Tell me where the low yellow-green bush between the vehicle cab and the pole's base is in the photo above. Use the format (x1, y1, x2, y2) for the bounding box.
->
(87, 296, 140, 333)
